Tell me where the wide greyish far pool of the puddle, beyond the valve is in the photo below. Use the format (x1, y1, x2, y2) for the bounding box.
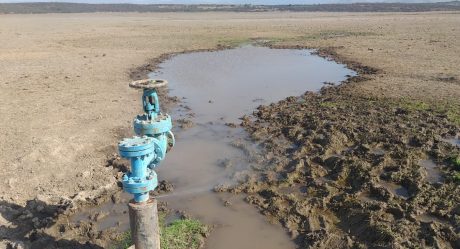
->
(155, 46, 355, 123)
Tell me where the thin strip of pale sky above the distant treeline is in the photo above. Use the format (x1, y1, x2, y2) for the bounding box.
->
(0, 0, 450, 4)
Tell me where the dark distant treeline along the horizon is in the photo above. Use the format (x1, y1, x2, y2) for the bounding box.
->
(0, 1, 460, 14)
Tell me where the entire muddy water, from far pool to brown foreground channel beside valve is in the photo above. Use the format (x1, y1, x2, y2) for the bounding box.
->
(146, 46, 354, 249)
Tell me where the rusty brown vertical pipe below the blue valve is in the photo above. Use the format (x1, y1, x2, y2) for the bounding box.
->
(128, 198, 160, 249)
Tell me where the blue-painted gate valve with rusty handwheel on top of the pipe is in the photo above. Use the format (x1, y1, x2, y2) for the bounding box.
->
(118, 79, 175, 202)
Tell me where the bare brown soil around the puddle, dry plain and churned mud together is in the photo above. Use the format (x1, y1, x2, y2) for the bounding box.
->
(0, 12, 460, 248)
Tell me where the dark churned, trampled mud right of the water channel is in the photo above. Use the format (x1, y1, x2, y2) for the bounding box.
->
(228, 83, 460, 248)
